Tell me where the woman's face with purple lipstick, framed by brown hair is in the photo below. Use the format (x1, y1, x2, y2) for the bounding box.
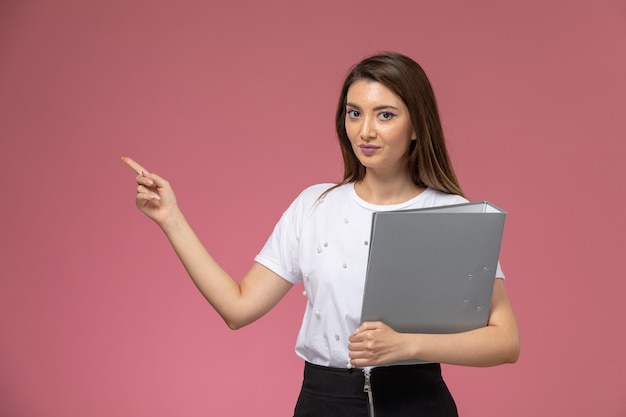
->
(345, 80, 415, 174)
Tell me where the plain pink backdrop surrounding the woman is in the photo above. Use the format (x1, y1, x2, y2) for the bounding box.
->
(0, 0, 626, 417)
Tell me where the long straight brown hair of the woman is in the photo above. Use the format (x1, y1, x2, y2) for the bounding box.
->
(329, 52, 463, 195)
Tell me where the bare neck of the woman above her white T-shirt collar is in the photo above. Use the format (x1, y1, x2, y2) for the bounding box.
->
(354, 173, 425, 205)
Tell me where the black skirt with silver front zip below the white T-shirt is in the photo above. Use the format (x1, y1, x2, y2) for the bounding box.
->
(294, 362, 458, 417)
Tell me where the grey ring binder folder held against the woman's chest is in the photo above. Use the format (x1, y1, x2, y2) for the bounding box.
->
(361, 201, 506, 363)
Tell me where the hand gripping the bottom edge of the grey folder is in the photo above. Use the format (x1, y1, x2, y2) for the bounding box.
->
(348, 321, 407, 367)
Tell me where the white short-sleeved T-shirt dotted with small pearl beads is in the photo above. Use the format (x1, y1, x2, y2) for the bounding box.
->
(255, 183, 503, 367)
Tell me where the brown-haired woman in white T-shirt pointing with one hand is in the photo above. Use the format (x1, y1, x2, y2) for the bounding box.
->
(123, 53, 519, 417)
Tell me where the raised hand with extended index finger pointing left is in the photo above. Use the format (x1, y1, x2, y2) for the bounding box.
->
(122, 156, 180, 227)
